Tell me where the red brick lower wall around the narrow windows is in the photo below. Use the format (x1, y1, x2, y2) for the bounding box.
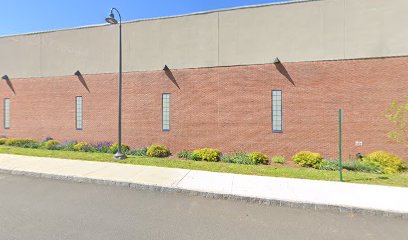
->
(0, 57, 408, 160)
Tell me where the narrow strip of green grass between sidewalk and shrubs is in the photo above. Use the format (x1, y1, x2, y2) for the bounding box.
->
(0, 146, 408, 187)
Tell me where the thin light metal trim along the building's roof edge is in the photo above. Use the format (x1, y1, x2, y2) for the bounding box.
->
(0, 0, 323, 39)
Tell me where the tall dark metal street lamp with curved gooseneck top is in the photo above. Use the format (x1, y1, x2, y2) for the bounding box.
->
(105, 8, 126, 160)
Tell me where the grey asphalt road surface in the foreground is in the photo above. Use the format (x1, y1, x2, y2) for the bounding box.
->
(0, 174, 408, 240)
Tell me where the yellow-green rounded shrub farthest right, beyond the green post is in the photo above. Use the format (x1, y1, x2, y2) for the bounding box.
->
(362, 151, 405, 174)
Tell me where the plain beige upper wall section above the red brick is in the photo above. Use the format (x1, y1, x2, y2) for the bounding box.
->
(0, 0, 408, 78)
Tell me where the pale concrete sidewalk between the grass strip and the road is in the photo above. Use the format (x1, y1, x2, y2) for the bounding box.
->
(0, 154, 408, 218)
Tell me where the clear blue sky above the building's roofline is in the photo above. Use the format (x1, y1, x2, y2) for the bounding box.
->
(0, 0, 287, 36)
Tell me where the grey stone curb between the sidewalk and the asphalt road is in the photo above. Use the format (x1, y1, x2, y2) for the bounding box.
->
(0, 168, 408, 219)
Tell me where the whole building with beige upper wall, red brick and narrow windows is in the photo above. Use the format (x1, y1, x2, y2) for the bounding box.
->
(0, 0, 408, 160)
